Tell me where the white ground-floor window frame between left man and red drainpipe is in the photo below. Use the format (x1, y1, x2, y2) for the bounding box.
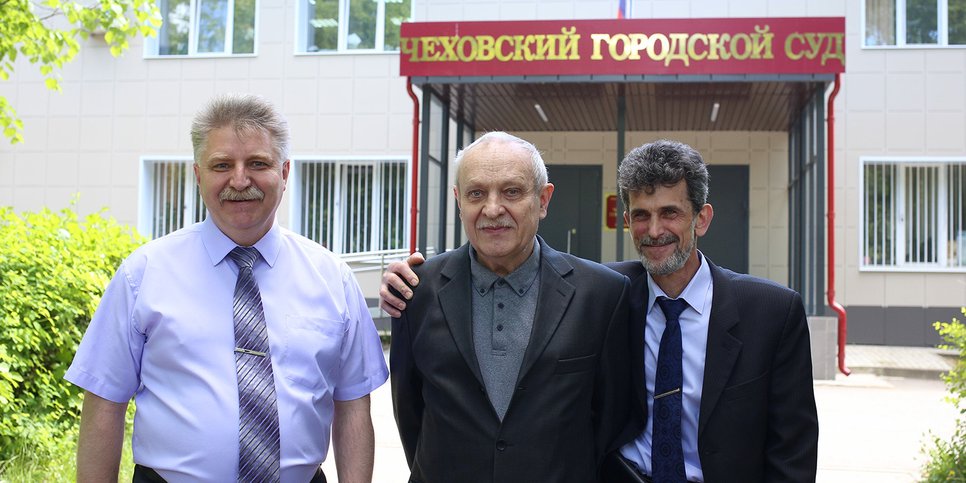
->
(288, 155, 412, 259)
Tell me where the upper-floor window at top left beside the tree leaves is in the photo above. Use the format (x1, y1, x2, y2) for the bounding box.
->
(144, 0, 257, 56)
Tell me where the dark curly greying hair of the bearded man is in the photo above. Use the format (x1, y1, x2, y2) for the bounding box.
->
(617, 139, 709, 213)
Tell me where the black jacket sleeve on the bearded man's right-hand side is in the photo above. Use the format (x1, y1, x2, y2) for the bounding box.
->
(764, 293, 818, 482)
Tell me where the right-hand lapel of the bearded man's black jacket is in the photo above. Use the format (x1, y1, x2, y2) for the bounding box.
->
(698, 258, 741, 439)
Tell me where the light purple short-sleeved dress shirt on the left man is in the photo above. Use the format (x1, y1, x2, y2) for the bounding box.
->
(65, 219, 389, 483)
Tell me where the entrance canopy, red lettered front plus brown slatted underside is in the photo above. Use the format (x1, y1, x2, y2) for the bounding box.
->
(400, 17, 845, 131)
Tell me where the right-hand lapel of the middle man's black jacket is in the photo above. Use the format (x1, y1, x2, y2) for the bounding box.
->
(517, 240, 575, 381)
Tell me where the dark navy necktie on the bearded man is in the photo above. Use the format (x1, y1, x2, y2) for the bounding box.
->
(651, 297, 688, 483)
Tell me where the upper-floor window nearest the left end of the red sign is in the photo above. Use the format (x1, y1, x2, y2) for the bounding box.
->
(296, 0, 413, 52)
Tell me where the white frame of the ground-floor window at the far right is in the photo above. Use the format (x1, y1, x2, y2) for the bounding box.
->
(856, 156, 966, 273)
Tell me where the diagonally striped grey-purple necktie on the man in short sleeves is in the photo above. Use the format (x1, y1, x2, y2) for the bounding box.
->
(228, 247, 280, 483)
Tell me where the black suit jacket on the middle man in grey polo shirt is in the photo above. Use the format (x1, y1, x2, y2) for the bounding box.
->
(390, 237, 632, 483)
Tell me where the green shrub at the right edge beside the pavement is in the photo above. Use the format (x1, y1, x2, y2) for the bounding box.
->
(923, 307, 966, 483)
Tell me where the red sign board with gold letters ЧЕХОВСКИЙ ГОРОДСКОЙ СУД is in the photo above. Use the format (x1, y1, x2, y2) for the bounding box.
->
(399, 17, 845, 76)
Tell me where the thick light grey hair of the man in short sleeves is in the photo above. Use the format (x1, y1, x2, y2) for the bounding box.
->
(191, 94, 289, 164)
